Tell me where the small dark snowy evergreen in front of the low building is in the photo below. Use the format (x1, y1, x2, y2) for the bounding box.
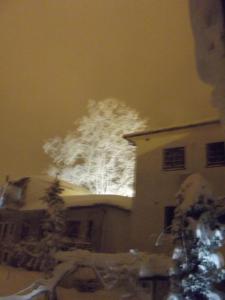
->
(2, 178, 69, 273)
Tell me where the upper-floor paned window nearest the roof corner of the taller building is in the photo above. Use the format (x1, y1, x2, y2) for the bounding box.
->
(163, 147, 185, 170)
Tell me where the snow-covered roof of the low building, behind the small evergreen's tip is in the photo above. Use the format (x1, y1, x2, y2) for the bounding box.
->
(15, 176, 132, 211)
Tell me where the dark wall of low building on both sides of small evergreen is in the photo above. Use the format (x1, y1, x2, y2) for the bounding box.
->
(0, 205, 130, 252)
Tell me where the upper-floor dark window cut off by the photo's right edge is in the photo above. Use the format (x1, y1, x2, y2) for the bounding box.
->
(206, 142, 225, 167)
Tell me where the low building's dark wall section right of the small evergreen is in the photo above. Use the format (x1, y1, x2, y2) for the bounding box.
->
(67, 205, 130, 252)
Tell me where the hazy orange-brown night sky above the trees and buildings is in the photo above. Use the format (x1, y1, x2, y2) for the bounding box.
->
(0, 0, 217, 177)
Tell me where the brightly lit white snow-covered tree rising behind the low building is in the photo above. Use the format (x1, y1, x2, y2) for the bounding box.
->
(43, 99, 146, 196)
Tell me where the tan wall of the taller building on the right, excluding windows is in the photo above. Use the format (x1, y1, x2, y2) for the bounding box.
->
(131, 124, 225, 252)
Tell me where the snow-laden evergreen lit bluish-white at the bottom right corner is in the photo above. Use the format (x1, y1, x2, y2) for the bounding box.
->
(168, 175, 225, 300)
